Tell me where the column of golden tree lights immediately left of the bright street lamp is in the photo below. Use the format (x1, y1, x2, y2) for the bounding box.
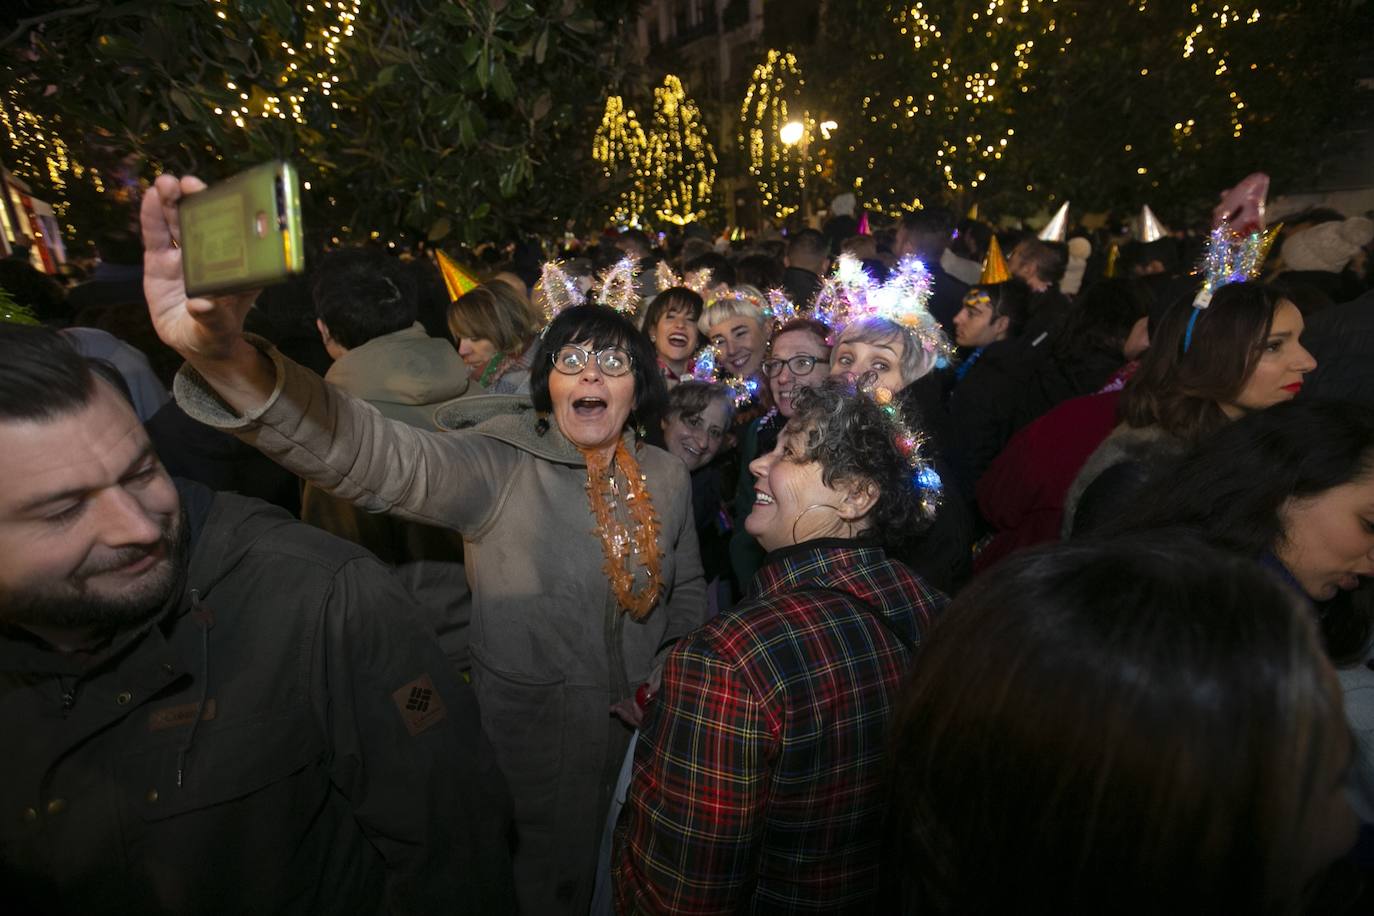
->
(739, 49, 820, 220)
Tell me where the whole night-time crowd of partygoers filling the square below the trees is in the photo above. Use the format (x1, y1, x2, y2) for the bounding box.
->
(0, 168, 1374, 915)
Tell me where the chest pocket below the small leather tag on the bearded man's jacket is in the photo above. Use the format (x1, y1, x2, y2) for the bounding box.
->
(117, 713, 327, 821)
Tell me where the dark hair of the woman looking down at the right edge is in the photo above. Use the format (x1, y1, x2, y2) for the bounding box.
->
(1103, 400, 1374, 665)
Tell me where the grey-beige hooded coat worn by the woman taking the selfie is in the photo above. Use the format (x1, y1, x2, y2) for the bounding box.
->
(174, 346, 706, 916)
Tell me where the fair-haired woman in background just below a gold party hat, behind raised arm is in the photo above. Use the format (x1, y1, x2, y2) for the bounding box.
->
(448, 282, 544, 394)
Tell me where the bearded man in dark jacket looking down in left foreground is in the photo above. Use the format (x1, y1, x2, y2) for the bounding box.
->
(0, 325, 514, 913)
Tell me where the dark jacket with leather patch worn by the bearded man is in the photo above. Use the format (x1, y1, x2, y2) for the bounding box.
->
(0, 482, 514, 915)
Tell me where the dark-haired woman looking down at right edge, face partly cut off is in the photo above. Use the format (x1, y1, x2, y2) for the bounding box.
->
(1103, 398, 1374, 828)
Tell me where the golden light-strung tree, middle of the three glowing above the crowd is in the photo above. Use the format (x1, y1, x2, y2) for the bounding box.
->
(644, 74, 716, 225)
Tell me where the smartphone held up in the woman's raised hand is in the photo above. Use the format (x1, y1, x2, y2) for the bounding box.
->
(177, 161, 305, 295)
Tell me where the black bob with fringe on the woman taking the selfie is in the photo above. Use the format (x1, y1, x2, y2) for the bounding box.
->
(529, 305, 668, 422)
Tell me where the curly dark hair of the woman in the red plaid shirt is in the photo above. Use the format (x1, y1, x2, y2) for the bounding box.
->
(787, 376, 930, 551)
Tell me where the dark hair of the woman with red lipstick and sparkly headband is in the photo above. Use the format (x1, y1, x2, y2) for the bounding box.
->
(1117, 283, 1282, 442)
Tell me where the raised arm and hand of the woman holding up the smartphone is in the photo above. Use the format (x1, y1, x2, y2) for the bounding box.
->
(142, 174, 510, 531)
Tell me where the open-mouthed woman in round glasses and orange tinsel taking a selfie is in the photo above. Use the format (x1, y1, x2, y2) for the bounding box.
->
(142, 176, 705, 913)
